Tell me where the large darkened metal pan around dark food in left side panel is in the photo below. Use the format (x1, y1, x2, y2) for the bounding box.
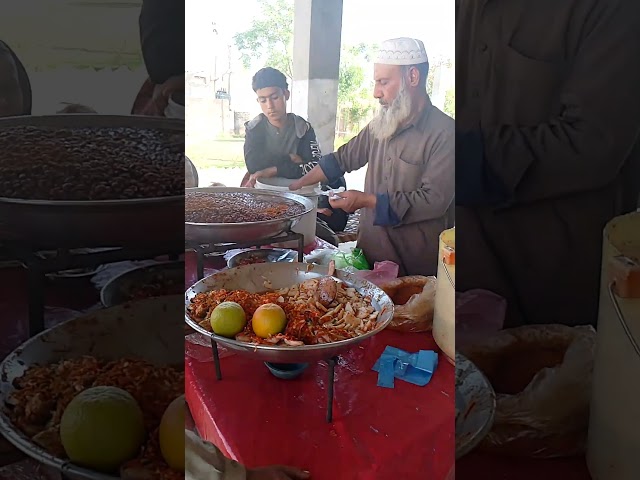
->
(0, 114, 184, 249)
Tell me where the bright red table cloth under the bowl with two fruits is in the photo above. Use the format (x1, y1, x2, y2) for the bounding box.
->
(185, 331, 455, 480)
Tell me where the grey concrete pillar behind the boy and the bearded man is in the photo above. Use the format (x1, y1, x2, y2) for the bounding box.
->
(291, 0, 343, 154)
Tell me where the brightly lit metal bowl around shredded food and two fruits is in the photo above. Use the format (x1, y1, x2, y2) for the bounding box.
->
(185, 263, 393, 363)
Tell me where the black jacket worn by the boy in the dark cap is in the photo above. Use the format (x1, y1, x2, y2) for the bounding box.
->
(244, 113, 346, 188)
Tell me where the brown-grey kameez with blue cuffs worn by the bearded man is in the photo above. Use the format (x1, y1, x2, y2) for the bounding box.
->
(320, 102, 455, 275)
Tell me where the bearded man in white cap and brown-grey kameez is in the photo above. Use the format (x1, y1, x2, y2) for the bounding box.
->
(290, 38, 455, 275)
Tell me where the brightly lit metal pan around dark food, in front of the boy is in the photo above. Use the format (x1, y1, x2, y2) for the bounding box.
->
(184, 187, 315, 245)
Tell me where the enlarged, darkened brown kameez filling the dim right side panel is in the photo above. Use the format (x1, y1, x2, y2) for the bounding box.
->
(456, 0, 640, 325)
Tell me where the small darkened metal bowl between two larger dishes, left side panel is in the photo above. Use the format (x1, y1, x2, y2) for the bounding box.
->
(100, 260, 184, 307)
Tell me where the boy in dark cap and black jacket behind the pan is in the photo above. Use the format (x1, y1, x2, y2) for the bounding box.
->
(242, 67, 348, 232)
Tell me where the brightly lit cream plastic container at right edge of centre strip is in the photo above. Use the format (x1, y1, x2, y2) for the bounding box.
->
(433, 227, 456, 364)
